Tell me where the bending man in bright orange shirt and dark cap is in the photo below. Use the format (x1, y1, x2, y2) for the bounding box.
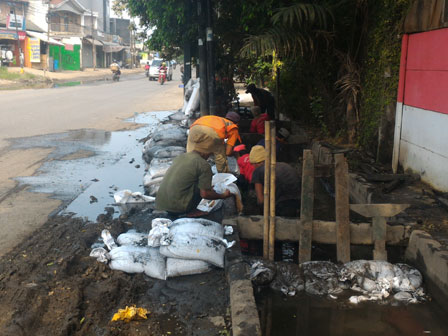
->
(187, 112, 241, 173)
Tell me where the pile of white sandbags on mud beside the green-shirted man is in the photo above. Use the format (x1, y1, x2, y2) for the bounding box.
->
(90, 218, 232, 280)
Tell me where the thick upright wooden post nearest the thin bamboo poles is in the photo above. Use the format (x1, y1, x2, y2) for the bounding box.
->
(299, 149, 314, 263)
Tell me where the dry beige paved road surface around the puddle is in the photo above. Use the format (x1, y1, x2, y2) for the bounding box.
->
(0, 70, 183, 255)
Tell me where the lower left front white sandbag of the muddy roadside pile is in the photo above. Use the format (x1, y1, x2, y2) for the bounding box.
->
(109, 245, 166, 280)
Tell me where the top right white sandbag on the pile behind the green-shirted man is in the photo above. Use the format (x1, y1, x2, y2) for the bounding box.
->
(169, 218, 224, 239)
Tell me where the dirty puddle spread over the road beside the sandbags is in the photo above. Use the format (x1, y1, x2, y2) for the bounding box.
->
(12, 111, 174, 221)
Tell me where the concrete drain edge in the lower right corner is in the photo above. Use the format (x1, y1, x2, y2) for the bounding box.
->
(405, 230, 448, 308)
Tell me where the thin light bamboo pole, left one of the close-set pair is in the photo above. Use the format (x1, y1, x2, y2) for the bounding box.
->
(263, 121, 271, 259)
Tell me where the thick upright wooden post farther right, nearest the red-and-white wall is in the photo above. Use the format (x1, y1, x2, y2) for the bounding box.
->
(334, 154, 350, 263)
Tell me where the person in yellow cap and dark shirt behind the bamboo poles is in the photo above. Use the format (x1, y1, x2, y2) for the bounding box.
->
(249, 146, 301, 217)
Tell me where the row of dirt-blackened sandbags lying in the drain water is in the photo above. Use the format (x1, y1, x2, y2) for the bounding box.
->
(250, 260, 426, 304)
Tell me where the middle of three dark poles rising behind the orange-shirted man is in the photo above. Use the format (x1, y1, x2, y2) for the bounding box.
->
(197, 0, 210, 116)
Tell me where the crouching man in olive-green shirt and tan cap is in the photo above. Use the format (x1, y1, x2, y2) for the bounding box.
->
(156, 130, 231, 215)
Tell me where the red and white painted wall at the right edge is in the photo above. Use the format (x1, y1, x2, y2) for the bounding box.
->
(392, 29, 448, 191)
